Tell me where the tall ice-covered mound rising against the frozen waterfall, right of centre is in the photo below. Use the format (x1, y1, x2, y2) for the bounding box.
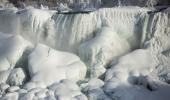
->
(79, 26, 130, 77)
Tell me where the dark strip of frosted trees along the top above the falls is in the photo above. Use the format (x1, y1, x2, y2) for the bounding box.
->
(4, 0, 170, 7)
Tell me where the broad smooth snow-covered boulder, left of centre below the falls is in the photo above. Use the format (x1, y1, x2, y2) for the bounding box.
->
(29, 44, 86, 86)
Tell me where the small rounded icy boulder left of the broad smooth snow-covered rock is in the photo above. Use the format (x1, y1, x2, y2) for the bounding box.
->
(7, 68, 26, 86)
